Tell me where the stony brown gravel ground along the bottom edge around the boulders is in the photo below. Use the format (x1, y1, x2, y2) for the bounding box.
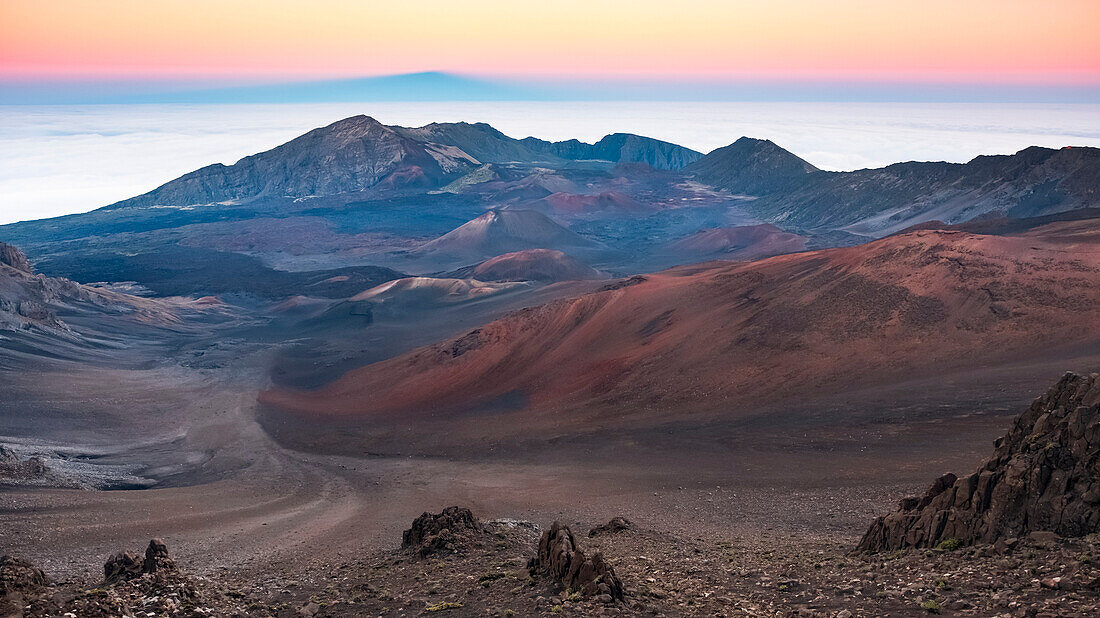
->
(0, 516, 1100, 618)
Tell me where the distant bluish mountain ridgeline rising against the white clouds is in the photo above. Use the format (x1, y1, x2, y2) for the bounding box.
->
(94, 115, 1100, 235)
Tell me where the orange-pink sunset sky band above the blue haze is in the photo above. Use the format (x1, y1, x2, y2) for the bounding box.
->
(0, 0, 1100, 85)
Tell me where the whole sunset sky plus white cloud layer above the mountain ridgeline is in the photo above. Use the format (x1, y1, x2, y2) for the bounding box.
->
(0, 0, 1100, 222)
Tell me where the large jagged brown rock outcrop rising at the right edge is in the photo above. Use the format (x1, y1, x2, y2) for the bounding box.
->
(857, 373, 1100, 552)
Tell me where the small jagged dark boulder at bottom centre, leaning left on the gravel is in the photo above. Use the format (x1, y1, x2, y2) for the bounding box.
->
(527, 521, 623, 603)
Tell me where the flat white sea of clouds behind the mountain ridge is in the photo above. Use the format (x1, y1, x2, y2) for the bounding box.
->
(0, 101, 1100, 225)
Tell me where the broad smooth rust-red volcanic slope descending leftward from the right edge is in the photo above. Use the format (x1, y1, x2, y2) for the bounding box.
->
(262, 231, 1100, 431)
